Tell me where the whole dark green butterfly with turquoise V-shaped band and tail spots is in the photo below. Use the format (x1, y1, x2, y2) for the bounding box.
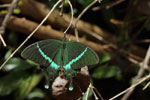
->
(21, 39, 99, 91)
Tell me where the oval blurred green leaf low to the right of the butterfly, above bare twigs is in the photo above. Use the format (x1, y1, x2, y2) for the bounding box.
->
(92, 66, 121, 79)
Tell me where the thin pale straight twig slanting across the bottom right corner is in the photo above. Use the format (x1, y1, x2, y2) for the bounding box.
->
(109, 74, 150, 100)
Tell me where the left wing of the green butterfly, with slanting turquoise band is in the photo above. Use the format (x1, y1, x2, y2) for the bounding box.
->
(21, 39, 62, 66)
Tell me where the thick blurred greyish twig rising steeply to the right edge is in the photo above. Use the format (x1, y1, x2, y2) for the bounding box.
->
(121, 46, 150, 100)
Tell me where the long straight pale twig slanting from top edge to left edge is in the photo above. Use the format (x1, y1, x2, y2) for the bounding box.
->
(0, 0, 62, 70)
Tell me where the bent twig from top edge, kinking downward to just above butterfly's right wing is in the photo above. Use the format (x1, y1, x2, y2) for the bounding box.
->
(73, 0, 102, 41)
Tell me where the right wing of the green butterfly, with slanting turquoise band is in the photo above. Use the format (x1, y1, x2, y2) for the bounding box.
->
(64, 41, 99, 69)
